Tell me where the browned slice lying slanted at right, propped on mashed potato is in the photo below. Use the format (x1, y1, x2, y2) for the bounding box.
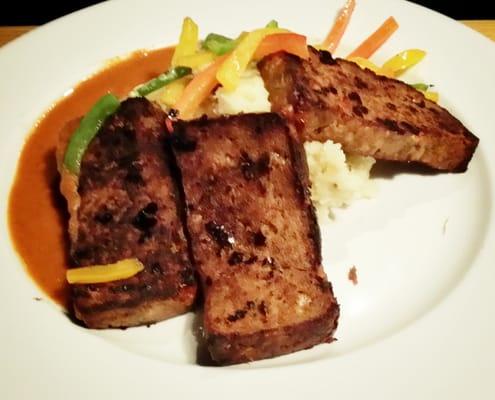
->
(258, 47, 478, 172)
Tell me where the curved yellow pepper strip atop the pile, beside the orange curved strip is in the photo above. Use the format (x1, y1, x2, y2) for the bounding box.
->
(217, 28, 286, 91)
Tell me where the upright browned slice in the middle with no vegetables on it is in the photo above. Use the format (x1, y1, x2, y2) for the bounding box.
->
(172, 113, 339, 364)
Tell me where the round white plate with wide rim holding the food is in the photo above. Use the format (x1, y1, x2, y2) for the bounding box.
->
(0, 0, 495, 399)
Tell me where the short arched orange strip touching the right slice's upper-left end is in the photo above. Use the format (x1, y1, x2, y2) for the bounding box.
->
(253, 33, 309, 60)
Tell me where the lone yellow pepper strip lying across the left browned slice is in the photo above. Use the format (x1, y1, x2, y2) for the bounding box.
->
(66, 258, 144, 284)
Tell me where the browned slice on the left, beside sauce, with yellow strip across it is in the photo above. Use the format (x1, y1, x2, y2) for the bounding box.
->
(62, 99, 196, 328)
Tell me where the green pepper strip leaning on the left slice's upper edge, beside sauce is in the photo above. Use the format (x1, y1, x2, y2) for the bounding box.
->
(64, 93, 120, 175)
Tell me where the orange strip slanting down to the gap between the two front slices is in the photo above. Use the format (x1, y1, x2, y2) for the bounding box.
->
(175, 55, 227, 119)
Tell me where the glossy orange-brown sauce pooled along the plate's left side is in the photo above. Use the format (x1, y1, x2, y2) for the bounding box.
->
(8, 48, 173, 307)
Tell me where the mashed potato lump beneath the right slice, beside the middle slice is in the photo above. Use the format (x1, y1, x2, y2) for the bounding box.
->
(304, 140, 376, 217)
